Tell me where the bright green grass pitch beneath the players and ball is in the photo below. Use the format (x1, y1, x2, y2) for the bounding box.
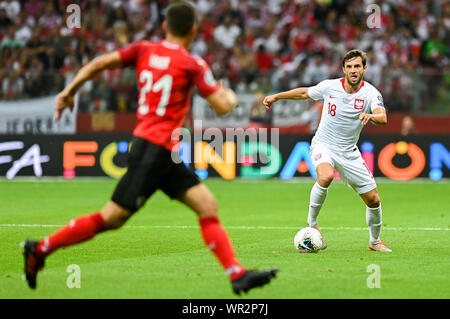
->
(0, 179, 450, 299)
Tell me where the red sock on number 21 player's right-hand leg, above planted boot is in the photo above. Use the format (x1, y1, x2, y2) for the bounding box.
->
(199, 217, 245, 280)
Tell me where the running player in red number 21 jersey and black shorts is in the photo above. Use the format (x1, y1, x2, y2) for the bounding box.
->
(24, 1, 277, 294)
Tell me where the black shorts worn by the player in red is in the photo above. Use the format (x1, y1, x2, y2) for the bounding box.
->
(111, 137, 200, 212)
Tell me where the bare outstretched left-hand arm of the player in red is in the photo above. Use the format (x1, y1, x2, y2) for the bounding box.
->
(54, 51, 122, 121)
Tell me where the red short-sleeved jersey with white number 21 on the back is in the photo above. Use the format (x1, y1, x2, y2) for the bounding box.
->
(119, 41, 219, 150)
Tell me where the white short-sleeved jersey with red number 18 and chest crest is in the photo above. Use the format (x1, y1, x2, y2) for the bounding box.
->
(308, 78, 384, 151)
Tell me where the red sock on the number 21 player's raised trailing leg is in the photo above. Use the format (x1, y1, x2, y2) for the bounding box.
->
(37, 213, 105, 257)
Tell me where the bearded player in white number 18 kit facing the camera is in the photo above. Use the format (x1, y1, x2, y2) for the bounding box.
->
(263, 50, 391, 252)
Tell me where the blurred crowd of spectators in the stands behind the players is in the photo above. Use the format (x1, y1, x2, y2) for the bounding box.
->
(0, 0, 450, 111)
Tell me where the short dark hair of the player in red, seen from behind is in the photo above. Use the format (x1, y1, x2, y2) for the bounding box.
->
(166, 0, 197, 37)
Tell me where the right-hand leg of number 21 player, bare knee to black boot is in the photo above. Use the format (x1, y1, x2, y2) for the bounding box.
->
(178, 184, 278, 295)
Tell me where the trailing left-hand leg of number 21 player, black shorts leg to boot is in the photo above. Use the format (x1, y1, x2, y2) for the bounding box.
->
(24, 138, 163, 288)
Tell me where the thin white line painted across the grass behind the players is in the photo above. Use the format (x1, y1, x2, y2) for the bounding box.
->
(0, 224, 450, 231)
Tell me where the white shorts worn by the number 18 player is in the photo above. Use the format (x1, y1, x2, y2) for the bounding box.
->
(310, 143, 377, 195)
